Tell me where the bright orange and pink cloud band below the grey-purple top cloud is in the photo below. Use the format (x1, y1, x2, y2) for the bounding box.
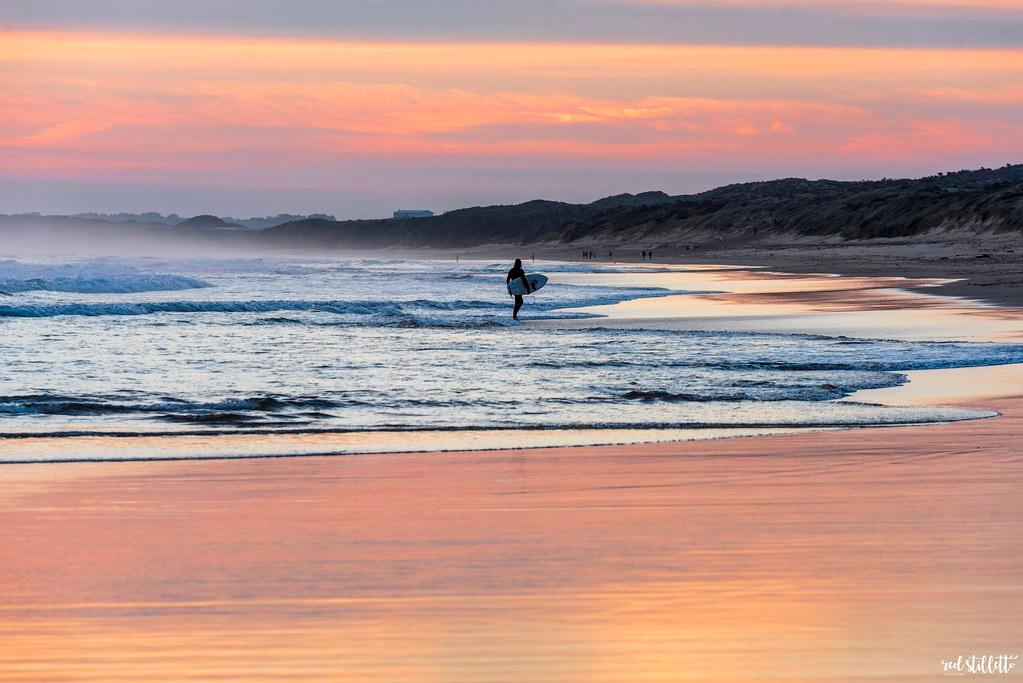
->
(0, 32, 1023, 177)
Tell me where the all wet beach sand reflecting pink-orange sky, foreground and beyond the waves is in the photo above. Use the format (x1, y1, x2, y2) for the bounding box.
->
(0, 259, 1023, 681)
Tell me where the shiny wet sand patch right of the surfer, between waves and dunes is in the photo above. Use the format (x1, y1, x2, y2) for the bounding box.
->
(540, 264, 1023, 342)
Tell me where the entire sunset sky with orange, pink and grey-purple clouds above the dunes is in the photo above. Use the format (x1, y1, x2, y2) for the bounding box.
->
(0, 0, 1023, 217)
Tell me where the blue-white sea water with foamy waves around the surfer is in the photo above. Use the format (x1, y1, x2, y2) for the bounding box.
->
(0, 259, 1023, 460)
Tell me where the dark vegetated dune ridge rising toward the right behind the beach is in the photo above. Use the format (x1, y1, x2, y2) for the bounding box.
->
(262, 165, 1023, 248)
